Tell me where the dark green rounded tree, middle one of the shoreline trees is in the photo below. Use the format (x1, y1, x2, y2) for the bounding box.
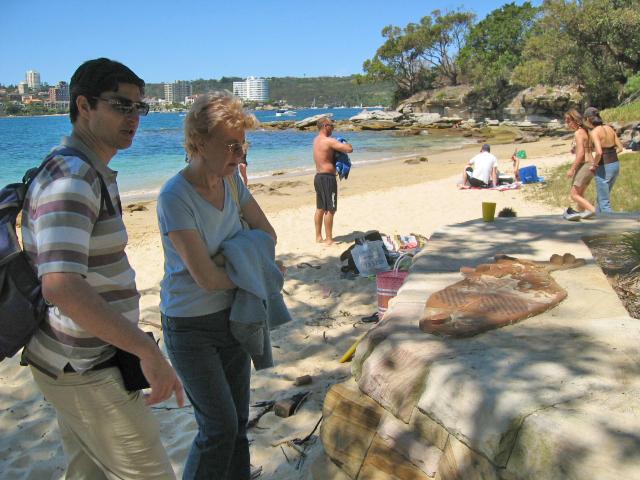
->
(458, 2, 538, 108)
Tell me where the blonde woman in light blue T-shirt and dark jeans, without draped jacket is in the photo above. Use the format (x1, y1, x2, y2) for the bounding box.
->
(158, 94, 276, 480)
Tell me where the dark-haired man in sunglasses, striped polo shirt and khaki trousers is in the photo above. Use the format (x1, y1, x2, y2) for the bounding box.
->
(22, 58, 183, 479)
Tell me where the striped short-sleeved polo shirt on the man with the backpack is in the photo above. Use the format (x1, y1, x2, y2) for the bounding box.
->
(22, 136, 140, 376)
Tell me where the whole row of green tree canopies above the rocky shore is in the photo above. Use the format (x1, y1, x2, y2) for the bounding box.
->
(363, 0, 640, 108)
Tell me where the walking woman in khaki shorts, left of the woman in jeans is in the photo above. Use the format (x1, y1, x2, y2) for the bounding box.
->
(562, 109, 595, 222)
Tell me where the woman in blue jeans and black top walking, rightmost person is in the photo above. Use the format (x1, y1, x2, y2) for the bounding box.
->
(584, 107, 623, 213)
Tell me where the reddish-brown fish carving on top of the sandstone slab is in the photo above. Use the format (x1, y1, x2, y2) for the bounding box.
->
(420, 253, 585, 337)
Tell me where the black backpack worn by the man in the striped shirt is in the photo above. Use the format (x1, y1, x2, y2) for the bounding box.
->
(0, 147, 115, 361)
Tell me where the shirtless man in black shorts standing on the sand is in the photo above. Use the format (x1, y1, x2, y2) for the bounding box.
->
(313, 117, 353, 244)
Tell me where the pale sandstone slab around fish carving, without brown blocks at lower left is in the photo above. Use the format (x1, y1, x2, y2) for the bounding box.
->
(353, 214, 640, 479)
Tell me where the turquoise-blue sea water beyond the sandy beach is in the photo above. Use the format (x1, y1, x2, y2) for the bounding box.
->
(0, 108, 464, 198)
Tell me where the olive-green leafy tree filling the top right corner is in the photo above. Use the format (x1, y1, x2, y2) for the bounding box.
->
(512, 0, 640, 107)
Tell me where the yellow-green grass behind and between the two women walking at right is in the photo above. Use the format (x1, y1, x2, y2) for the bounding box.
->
(526, 153, 640, 212)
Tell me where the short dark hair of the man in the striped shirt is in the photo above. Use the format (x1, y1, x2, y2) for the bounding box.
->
(69, 58, 144, 123)
